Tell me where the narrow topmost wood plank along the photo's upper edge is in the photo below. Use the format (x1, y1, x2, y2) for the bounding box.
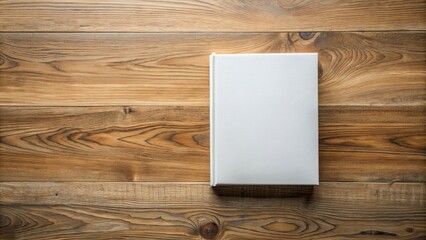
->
(0, 0, 426, 32)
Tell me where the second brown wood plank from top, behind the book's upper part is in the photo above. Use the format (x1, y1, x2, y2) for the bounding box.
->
(0, 32, 426, 106)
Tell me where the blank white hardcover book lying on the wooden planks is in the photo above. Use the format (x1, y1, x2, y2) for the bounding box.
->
(210, 53, 319, 186)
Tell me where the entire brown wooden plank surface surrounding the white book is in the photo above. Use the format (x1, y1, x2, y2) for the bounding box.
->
(0, 0, 426, 239)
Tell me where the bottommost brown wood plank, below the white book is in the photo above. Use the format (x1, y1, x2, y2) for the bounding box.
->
(0, 183, 426, 239)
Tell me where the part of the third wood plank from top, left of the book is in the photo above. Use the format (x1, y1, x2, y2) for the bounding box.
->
(0, 106, 209, 181)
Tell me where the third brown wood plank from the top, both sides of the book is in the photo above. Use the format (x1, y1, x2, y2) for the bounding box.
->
(0, 106, 426, 181)
